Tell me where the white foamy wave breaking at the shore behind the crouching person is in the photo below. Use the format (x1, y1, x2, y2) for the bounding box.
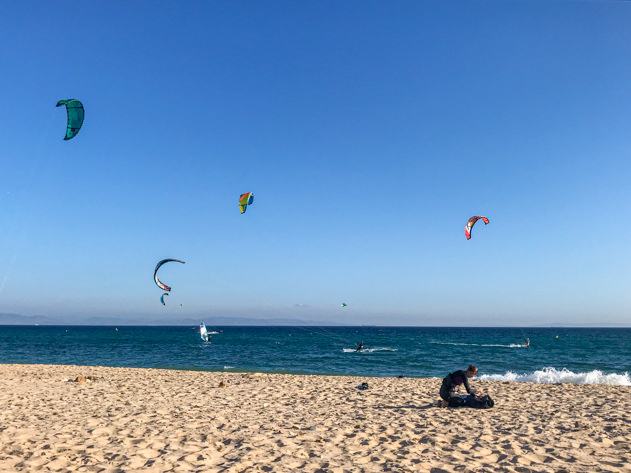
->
(478, 368, 631, 386)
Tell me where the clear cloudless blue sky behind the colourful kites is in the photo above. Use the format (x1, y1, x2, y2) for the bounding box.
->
(0, 0, 631, 326)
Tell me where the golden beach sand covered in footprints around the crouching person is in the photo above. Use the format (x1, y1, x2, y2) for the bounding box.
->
(0, 365, 631, 473)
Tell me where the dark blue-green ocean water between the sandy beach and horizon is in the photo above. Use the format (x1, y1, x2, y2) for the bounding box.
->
(0, 325, 631, 386)
